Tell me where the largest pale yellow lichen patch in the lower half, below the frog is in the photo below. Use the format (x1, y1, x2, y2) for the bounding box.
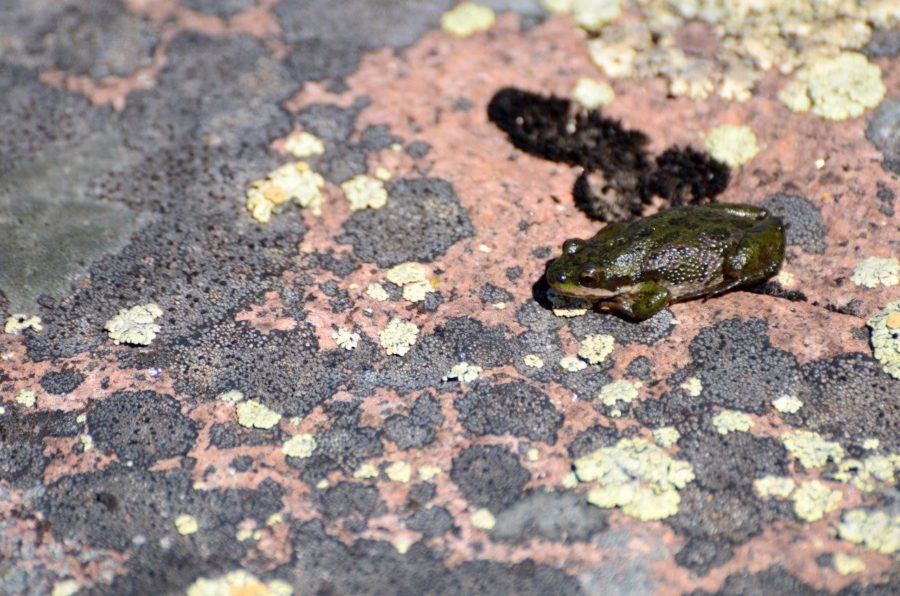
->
(575, 438, 694, 520)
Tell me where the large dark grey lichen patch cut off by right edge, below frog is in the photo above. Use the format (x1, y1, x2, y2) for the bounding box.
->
(785, 353, 900, 452)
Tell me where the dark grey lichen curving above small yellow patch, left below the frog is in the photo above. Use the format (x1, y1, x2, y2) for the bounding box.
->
(374, 317, 514, 393)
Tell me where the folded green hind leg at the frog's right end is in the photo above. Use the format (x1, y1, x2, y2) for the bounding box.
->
(717, 217, 784, 293)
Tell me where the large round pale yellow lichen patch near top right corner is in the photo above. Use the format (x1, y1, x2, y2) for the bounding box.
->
(797, 52, 887, 120)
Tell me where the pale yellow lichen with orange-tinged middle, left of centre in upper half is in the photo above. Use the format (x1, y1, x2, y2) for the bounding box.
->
(247, 161, 325, 223)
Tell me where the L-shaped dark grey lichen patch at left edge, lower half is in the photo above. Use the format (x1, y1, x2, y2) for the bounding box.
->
(0, 407, 81, 487)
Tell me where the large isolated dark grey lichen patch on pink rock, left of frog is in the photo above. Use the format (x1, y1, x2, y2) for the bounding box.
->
(338, 178, 473, 267)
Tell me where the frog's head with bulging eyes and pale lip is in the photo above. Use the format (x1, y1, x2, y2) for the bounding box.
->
(547, 238, 637, 300)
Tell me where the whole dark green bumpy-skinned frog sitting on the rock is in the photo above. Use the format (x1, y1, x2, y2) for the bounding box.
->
(547, 204, 784, 320)
